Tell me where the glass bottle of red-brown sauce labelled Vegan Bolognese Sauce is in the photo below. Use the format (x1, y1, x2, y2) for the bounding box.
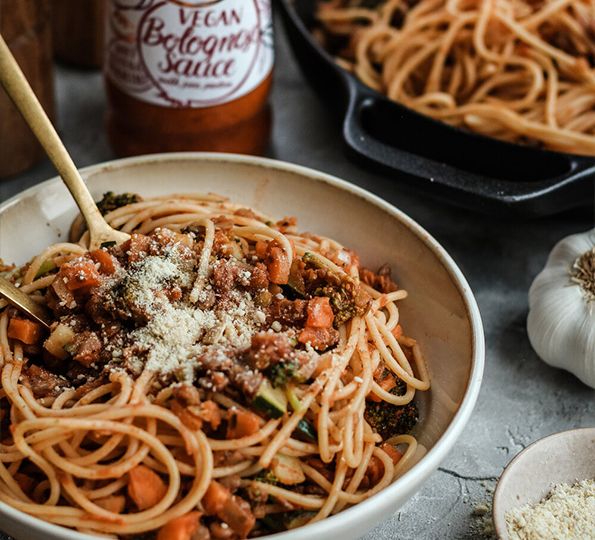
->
(104, 0, 273, 155)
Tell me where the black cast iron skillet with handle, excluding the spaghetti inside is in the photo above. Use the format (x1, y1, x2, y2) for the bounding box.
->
(280, 0, 595, 216)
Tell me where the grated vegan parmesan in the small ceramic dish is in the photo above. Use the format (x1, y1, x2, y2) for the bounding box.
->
(506, 480, 595, 540)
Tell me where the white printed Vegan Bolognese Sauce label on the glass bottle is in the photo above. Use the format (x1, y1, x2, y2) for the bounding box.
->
(104, 0, 274, 107)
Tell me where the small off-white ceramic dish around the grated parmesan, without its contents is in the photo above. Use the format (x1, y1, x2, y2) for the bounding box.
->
(493, 428, 595, 540)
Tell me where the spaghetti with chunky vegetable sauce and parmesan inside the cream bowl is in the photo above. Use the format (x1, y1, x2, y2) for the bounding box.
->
(0, 195, 430, 540)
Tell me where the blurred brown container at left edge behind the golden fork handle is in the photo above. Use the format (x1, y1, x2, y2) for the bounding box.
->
(0, 0, 54, 177)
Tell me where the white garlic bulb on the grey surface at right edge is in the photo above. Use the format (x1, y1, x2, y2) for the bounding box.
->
(527, 228, 595, 388)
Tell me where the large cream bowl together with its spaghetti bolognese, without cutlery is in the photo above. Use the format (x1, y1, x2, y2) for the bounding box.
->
(0, 153, 484, 540)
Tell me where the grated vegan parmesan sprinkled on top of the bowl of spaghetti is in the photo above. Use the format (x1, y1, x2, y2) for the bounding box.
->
(104, 238, 266, 383)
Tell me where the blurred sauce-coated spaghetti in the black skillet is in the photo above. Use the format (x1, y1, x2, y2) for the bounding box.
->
(318, 0, 595, 155)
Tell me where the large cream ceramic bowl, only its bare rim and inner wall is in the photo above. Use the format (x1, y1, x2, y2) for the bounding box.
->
(0, 153, 485, 540)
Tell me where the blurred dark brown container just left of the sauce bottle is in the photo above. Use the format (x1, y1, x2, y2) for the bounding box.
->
(52, 0, 105, 68)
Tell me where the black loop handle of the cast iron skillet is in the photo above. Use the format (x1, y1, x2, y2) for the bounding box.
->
(343, 84, 595, 214)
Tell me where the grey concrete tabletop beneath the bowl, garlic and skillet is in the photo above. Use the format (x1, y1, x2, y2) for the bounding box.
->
(0, 14, 595, 540)
